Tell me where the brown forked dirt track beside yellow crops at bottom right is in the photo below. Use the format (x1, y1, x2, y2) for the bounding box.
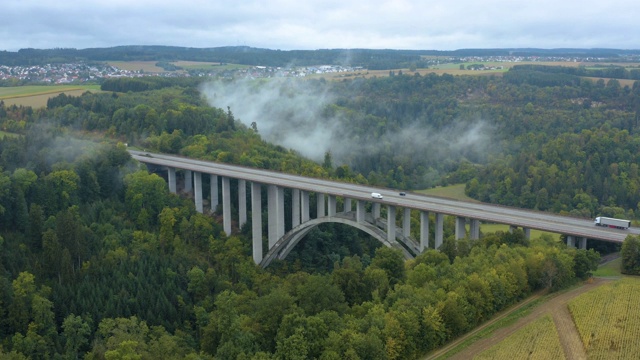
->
(426, 278, 611, 360)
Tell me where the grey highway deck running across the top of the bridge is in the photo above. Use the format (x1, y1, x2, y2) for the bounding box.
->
(129, 150, 640, 243)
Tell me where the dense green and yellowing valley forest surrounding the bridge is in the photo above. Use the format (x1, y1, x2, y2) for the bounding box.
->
(0, 64, 624, 359)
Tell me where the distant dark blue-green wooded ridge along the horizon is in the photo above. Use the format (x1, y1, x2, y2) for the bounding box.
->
(0, 45, 640, 70)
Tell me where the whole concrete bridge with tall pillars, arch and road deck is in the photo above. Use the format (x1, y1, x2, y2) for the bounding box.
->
(129, 150, 640, 267)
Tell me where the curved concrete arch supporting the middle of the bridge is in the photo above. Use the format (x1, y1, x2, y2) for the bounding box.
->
(260, 213, 413, 268)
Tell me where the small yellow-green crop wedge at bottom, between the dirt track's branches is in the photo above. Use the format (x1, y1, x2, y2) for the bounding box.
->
(474, 315, 565, 360)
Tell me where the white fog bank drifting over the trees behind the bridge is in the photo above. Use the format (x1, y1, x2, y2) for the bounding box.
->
(201, 78, 496, 170)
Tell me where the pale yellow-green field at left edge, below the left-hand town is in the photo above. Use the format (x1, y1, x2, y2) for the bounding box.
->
(0, 85, 100, 108)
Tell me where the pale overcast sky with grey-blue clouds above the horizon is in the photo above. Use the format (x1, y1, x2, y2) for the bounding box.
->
(0, 0, 640, 51)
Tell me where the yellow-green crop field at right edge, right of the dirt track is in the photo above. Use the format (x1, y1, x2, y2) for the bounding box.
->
(569, 277, 640, 359)
